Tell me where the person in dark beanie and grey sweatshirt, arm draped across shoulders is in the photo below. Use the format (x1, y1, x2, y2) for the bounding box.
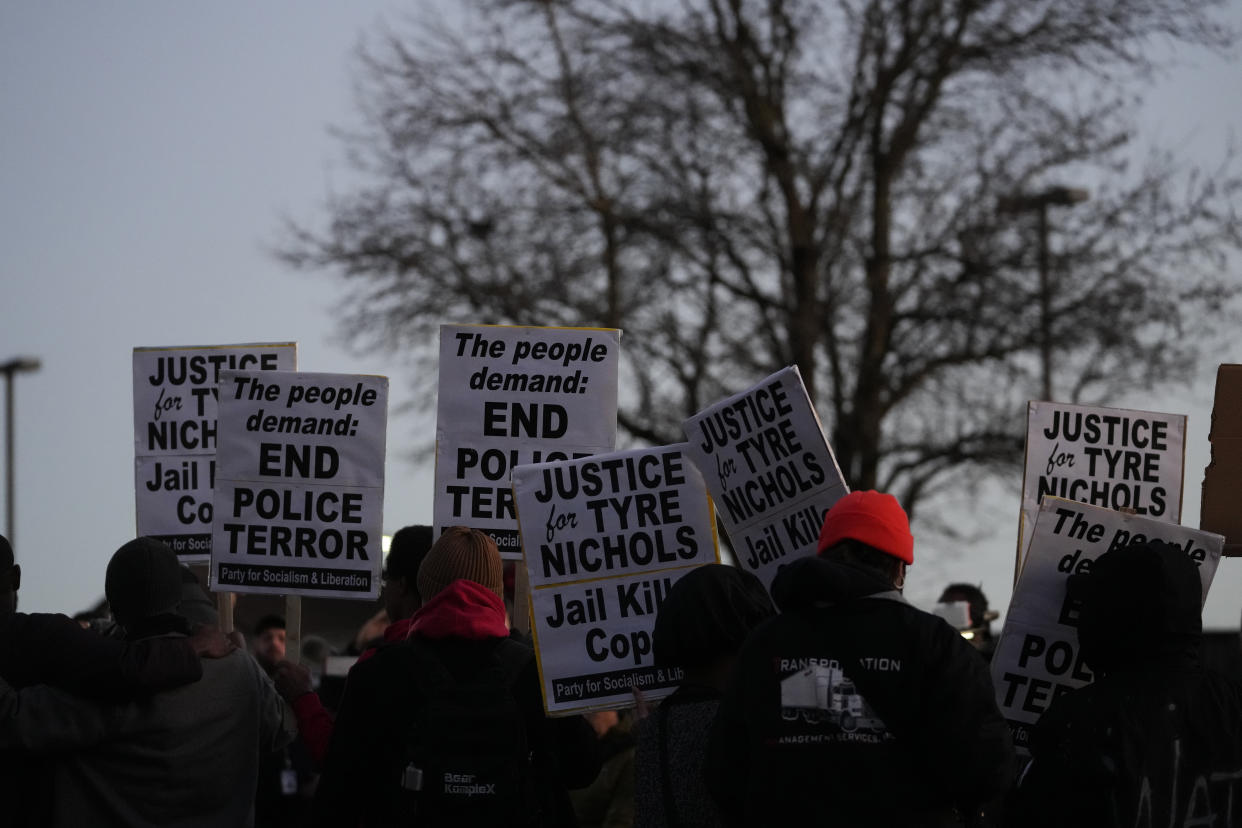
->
(0, 538, 292, 828)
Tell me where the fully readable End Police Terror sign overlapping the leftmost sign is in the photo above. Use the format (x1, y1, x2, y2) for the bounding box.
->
(211, 371, 388, 598)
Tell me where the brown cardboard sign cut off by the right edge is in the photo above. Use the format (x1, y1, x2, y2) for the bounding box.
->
(1199, 365, 1242, 555)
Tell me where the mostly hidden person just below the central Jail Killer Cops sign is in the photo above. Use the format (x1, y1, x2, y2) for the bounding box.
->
(569, 710, 635, 828)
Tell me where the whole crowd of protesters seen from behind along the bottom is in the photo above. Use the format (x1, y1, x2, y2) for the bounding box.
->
(0, 481, 1242, 828)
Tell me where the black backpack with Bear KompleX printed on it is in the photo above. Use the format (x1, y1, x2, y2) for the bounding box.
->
(389, 639, 540, 827)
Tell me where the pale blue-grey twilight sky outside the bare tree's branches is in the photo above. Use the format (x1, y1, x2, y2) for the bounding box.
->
(0, 0, 1242, 629)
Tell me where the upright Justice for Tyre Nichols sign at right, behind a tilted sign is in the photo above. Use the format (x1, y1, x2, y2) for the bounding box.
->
(1018, 402, 1186, 570)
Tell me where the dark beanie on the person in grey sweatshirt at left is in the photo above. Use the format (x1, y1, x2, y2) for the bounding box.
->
(103, 538, 181, 624)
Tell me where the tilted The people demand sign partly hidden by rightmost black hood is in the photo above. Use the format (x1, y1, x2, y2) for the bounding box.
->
(992, 497, 1223, 751)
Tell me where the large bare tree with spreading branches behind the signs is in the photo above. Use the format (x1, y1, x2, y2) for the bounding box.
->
(282, 0, 1242, 518)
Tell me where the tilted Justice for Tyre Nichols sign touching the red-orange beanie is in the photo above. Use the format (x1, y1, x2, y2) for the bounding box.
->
(683, 366, 850, 586)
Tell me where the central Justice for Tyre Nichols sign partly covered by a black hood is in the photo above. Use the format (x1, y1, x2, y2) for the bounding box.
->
(513, 444, 719, 715)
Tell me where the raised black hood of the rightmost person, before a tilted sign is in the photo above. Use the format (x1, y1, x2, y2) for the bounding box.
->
(1066, 541, 1203, 675)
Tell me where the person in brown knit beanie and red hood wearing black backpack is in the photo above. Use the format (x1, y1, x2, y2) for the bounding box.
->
(315, 526, 600, 826)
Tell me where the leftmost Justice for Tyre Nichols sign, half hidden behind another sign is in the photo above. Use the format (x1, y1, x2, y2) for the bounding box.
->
(133, 343, 297, 564)
